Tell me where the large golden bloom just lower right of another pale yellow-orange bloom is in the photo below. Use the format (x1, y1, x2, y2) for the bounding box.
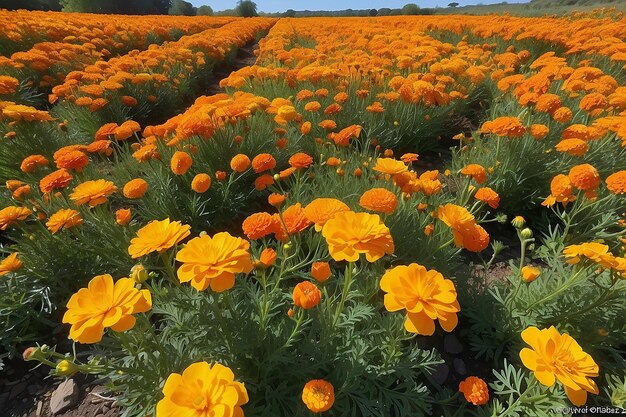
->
(176, 232, 253, 292)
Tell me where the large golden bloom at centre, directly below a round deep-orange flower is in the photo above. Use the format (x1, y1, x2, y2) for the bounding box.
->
(322, 211, 394, 262)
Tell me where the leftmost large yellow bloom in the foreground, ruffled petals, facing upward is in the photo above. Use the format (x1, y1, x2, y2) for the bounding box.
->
(63, 274, 152, 343)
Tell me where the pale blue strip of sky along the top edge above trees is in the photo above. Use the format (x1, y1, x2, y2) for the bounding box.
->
(189, 0, 529, 13)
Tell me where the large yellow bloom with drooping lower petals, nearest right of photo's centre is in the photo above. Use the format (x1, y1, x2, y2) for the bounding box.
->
(380, 263, 461, 335)
